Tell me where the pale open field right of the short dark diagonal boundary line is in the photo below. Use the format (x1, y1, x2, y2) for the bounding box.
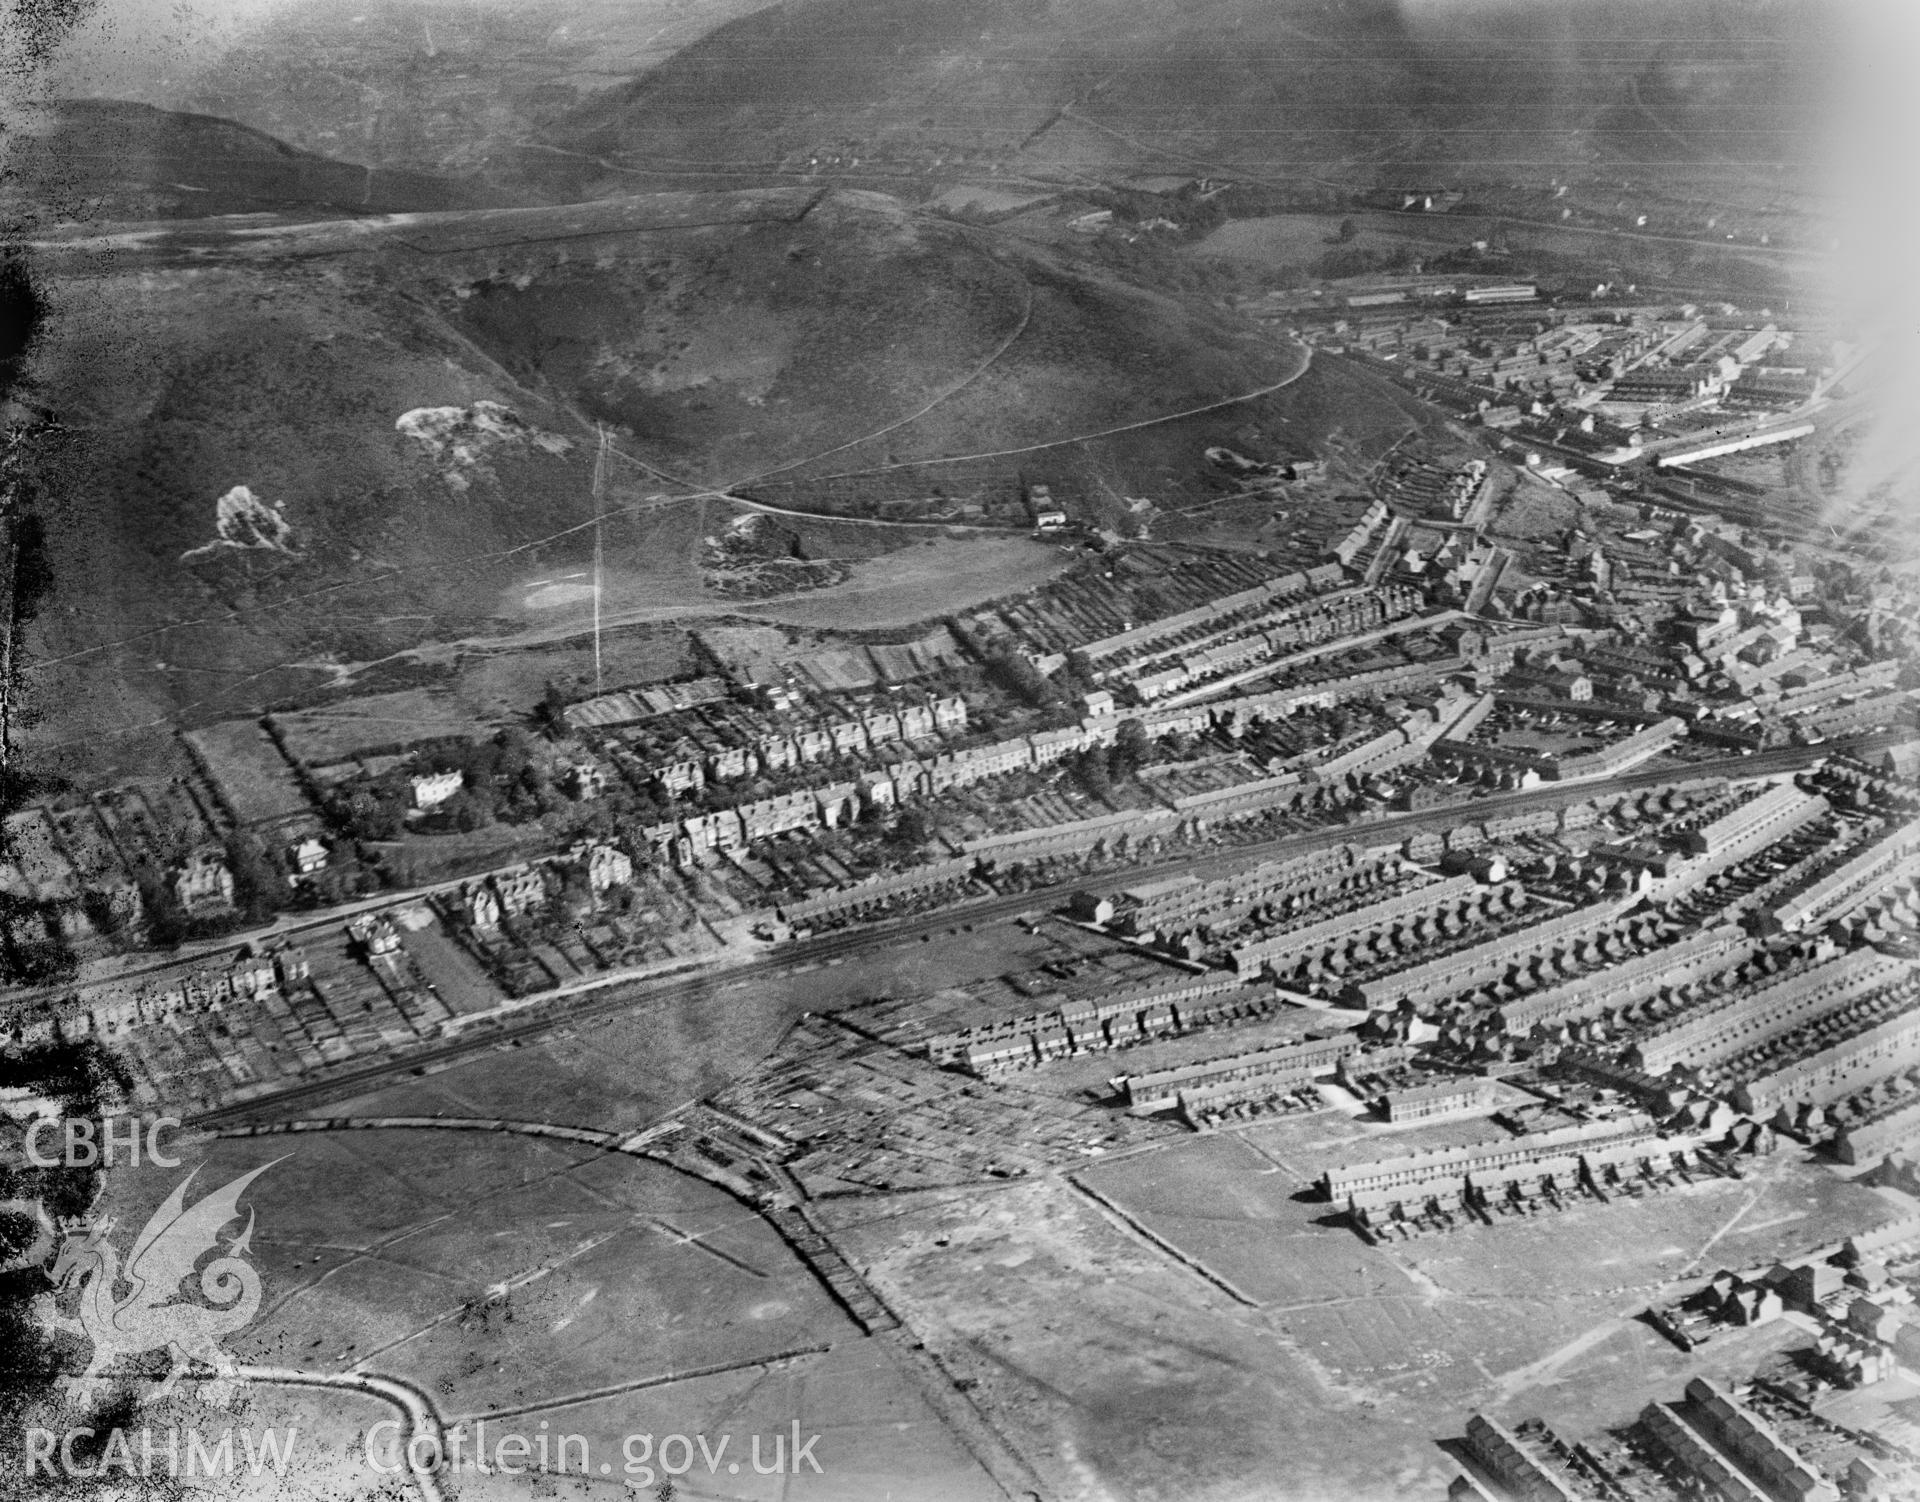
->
(1092, 1116, 1895, 1421)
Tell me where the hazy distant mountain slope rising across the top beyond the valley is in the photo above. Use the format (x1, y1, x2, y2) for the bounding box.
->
(522, 0, 1841, 192)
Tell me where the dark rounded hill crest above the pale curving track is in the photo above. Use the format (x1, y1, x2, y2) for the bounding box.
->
(420, 192, 1294, 484)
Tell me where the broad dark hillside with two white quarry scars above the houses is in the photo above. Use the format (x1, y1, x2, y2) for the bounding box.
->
(11, 179, 1404, 770)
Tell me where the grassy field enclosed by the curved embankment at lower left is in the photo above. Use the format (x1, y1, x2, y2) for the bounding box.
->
(76, 1131, 993, 1502)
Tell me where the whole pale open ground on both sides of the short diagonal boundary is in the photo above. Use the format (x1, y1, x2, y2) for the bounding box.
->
(810, 1112, 1899, 1502)
